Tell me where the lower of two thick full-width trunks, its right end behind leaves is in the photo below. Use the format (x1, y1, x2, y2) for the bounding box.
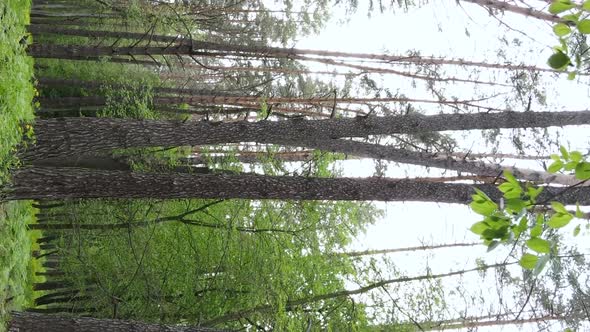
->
(6, 167, 590, 205)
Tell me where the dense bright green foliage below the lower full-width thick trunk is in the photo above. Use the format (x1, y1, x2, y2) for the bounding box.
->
(34, 151, 380, 330)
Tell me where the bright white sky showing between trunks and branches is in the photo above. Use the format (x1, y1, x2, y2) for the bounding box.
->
(295, 0, 590, 331)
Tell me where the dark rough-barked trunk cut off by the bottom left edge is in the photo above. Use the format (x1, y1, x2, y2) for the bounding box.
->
(8, 312, 228, 332)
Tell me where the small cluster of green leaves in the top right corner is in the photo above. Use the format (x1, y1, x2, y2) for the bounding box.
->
(548, 0, 590, 79)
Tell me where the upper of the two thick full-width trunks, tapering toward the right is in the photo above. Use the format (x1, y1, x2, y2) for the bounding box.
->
(28, 111, 590, 159)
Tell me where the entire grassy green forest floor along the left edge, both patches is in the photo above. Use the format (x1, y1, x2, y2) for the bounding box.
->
(0, 0, 39, 331)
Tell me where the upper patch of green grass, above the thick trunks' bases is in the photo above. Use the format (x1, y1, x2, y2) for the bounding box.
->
(0, 0, 35, 184)
